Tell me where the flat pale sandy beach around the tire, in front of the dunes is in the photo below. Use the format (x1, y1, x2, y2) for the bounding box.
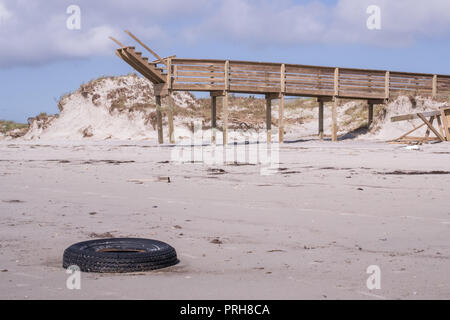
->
(0, 140, 450, 299)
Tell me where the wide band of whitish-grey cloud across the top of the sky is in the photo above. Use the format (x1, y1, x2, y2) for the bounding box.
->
(0, 0, 450, 67)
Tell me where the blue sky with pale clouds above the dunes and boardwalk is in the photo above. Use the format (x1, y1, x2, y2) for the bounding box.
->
(0, 0, 450, 122)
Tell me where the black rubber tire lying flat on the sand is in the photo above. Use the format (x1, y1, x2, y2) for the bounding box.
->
(63, 238, 179, 272)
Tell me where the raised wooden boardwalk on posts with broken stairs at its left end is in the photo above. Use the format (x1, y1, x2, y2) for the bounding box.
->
(111, 31, 450, 144)
